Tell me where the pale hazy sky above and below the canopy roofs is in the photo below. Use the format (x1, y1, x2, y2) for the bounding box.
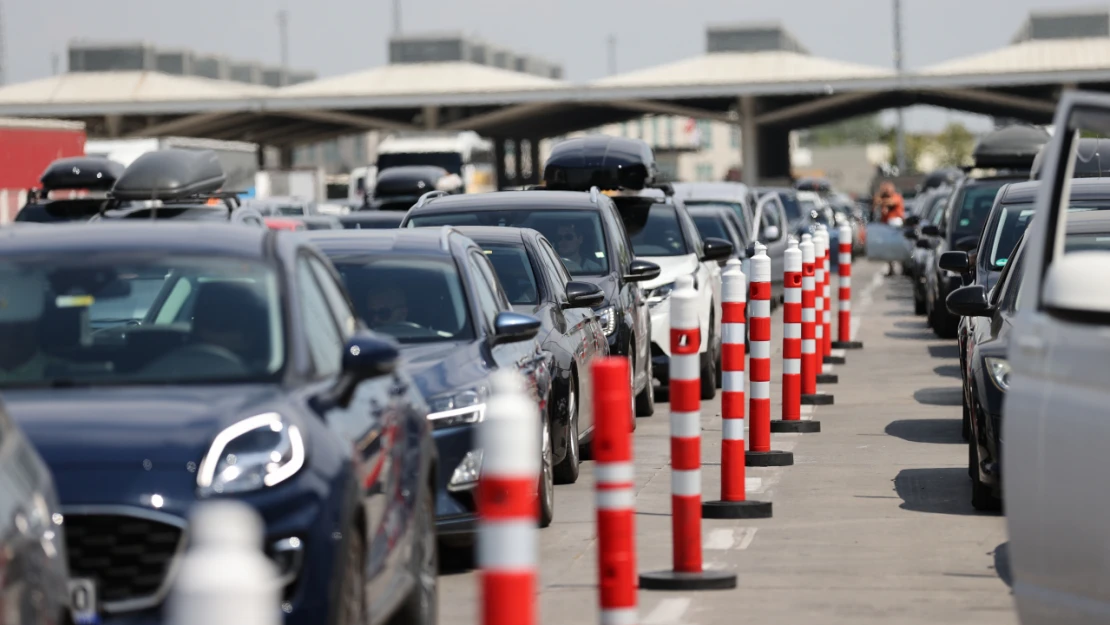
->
(0, 0, 1110, 130)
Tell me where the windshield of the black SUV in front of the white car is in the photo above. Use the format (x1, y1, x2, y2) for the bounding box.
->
(406, 209, 609, 276)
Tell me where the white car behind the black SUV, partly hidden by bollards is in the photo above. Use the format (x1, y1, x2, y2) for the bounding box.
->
(618, 193, 733, 400)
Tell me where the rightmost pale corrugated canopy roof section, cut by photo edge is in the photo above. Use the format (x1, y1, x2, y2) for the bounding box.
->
(918, 37, 1110, 75)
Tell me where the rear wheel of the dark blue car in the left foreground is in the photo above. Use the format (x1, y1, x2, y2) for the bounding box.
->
(390, 485, 440, 625)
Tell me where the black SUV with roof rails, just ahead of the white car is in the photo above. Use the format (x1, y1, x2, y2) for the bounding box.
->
(401, 189, 659, 416)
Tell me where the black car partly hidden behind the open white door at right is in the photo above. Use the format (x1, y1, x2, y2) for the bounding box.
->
(947, 212, 1110, 510)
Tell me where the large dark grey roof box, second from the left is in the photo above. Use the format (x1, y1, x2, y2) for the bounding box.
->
(112, 149, 228, 201)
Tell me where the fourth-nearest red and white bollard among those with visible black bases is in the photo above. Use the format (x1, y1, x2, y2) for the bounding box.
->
(770, 236, 821, 433)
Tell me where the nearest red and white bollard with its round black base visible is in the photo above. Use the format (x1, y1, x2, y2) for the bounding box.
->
(639, 275, 736, 591)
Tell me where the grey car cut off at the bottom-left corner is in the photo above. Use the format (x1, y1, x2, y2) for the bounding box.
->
(0, 399, 69, 625)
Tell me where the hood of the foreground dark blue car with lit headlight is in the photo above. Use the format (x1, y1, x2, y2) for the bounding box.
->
(3, 385, 280, 472)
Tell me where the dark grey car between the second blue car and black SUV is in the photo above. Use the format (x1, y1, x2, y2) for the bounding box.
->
(450, 226, 609, 484)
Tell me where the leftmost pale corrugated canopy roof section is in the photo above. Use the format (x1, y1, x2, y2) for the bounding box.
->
(0, 71, 274, 104)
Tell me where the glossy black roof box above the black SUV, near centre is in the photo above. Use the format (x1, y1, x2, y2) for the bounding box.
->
(544, 134, 658, 191)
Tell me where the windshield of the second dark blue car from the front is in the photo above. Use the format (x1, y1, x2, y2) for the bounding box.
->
(332, 254, 474, 343)
